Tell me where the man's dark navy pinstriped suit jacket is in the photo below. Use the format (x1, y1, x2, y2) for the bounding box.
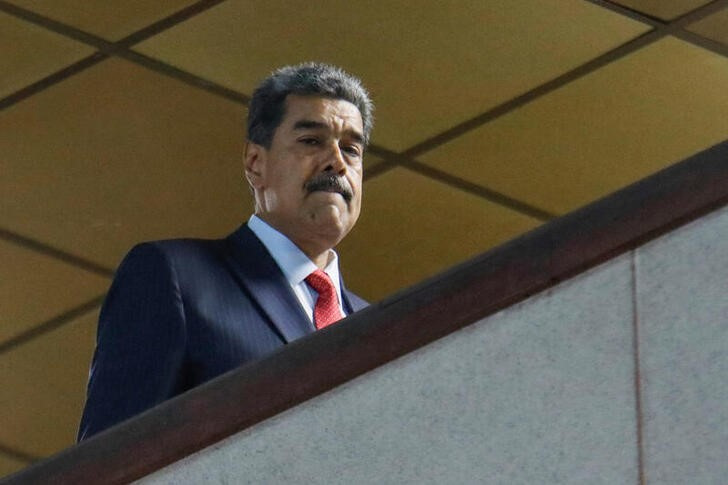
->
(78, 225, 366, 440)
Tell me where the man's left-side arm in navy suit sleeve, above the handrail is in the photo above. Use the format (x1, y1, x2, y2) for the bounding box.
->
(78, 243, 186, 441)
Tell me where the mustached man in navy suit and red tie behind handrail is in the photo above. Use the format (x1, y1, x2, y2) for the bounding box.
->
(79, 64, 372, 440)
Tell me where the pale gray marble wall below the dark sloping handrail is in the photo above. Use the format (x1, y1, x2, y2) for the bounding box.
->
(140, 202, 728, 484)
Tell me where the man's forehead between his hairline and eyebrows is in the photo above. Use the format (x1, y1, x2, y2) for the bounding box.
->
(281, 94, 364, 134)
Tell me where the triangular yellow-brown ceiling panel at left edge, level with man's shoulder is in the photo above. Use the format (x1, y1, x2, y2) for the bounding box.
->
(0, 240, 110, 342)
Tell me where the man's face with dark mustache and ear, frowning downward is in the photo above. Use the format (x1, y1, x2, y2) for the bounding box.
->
(245, 95, 364, 253)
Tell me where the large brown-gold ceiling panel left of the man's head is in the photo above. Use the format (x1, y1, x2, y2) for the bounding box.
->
(0, 59, 252, 267)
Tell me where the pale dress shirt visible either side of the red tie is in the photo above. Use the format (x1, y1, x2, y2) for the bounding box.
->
(248, 214, 346, 322)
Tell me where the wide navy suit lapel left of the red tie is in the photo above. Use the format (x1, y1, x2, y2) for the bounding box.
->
(224, 224, 314, 342)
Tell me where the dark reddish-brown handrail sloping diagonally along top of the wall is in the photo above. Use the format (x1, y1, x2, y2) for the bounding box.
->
(5, 140, 728, 485)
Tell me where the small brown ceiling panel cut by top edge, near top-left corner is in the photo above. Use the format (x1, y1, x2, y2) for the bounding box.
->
(11, 0, 195, 40)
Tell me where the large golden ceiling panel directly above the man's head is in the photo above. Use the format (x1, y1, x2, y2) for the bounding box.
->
(137, 0, 648, 150)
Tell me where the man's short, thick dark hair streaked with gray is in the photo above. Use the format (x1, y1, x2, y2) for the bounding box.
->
(248, 62, 374, 148)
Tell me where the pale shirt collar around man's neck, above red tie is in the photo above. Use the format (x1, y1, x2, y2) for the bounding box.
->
(248, 214, 341, 294)
